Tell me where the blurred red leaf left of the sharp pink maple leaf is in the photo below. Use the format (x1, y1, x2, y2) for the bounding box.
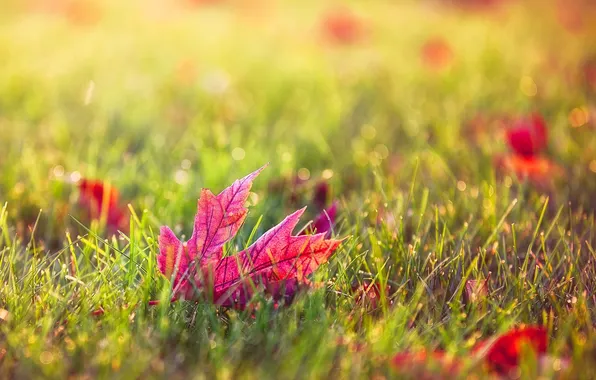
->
(78, 179, 128, 232)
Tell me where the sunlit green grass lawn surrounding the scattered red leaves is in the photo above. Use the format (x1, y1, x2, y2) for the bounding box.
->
(0, 0, 596, 379)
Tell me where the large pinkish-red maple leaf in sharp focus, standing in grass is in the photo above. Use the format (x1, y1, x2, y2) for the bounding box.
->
(157, 168, 340, 307)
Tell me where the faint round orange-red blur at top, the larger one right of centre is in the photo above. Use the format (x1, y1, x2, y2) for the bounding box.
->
(323, 8, 364, 45)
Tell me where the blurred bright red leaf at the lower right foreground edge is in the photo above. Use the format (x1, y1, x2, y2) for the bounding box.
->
(473, 326, 548, 375)
